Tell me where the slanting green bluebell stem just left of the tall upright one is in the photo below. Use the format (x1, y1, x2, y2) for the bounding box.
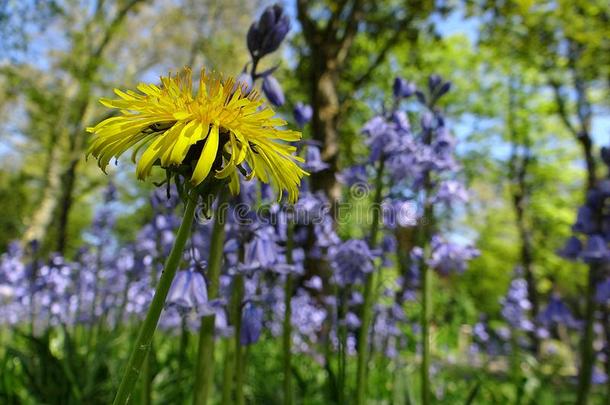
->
(356, 159, 384, 405)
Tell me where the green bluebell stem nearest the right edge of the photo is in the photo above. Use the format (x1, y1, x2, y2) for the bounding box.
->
(576, 265, 596, 405)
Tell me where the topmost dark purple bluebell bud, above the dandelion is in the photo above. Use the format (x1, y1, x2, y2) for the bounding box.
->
(247, 4, 290, 59)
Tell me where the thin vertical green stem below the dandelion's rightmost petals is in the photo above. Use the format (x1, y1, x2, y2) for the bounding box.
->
(282, 221, 294, 405)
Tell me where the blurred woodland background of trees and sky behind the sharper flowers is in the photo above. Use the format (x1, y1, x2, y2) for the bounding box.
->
(0, 0, 610, 404)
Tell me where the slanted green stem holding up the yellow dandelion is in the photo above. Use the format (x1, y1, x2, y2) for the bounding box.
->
(114, 193, 197, 405)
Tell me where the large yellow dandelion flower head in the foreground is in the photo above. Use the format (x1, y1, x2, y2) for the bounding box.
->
(87, 69, 307, 202)
